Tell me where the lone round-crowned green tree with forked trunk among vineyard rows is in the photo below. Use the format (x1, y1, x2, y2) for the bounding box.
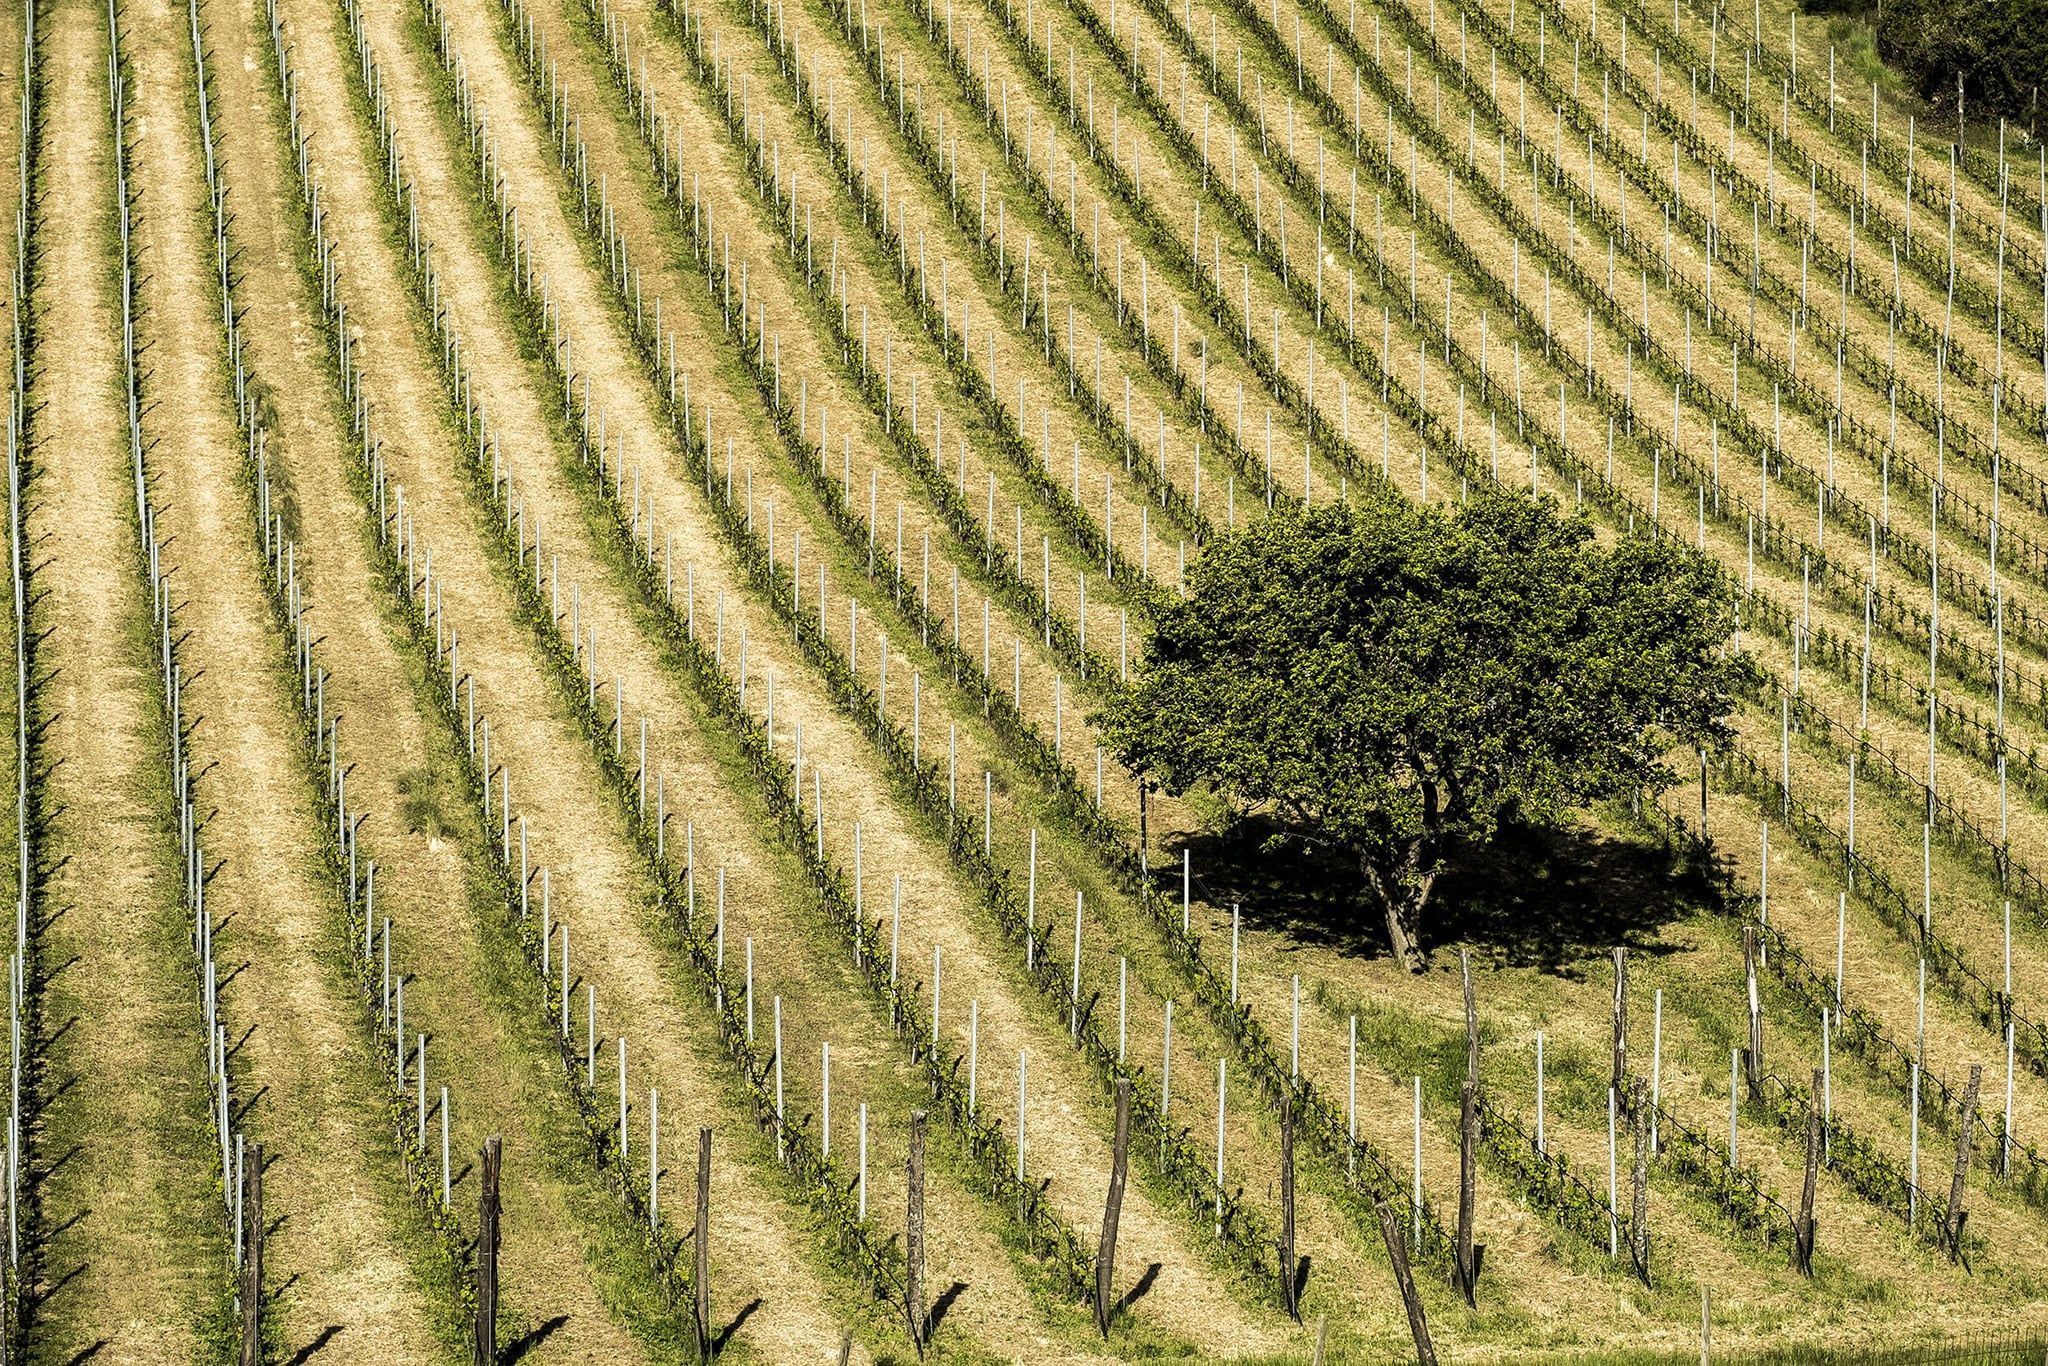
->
(1102, 494, 1747, 971)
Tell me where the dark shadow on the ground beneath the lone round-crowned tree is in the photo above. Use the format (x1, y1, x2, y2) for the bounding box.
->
(1169, 815, 1722, 977)
